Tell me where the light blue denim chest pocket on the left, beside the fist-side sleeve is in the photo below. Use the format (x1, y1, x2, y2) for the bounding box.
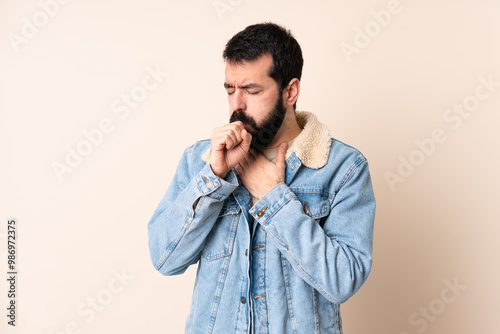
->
(201, 195, 241, 261)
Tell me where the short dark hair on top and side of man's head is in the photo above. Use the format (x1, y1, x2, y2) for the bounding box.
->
(222, 22, 304, 110)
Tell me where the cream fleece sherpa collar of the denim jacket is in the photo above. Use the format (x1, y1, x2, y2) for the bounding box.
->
(201, 111, 332, 169)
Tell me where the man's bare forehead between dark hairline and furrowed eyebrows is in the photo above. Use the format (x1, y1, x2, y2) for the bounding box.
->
(226, 54, 274, 84)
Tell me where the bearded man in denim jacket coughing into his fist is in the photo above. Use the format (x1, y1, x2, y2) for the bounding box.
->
(148, 23, 375, 334)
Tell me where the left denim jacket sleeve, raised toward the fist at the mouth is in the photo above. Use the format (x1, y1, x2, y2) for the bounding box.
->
(148, 146, 238, 275)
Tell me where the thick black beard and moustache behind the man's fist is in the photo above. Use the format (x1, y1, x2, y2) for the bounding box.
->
(229, 94, 286, 151)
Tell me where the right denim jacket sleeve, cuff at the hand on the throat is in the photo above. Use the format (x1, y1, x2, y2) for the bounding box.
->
(250, 156, 375, 303)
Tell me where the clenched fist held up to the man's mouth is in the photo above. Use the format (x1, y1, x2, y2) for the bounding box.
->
(210, 121, 252, 179)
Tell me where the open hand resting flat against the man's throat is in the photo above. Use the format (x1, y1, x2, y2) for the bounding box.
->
(235, 142, 288, 199)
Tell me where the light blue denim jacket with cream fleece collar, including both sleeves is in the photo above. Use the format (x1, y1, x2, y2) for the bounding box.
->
(148, 111, 375, 334)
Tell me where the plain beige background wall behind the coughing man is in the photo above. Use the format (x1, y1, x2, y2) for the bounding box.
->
(0, 0, 500, 334)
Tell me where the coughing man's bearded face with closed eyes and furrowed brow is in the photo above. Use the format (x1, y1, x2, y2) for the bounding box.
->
(224, 55, 286, 150)
